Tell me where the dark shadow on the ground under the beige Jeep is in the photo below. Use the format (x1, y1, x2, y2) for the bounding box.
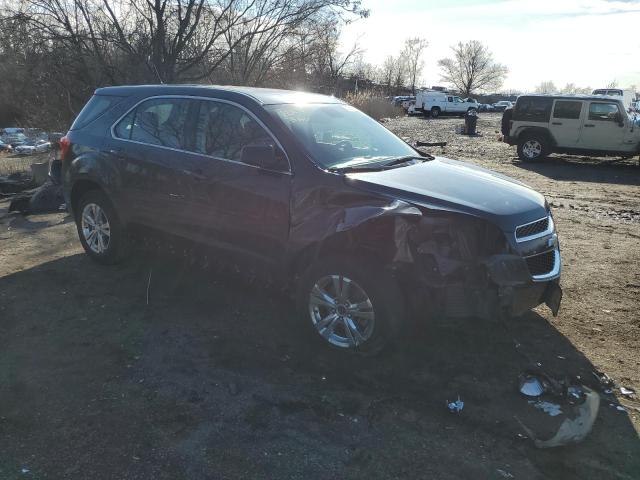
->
(512, 155, 640, 186)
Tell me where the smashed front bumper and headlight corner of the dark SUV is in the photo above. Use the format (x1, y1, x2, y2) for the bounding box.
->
(400, 212, 562, 318)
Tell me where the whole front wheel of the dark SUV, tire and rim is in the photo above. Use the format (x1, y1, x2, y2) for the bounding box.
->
(297, 258, 404, 354)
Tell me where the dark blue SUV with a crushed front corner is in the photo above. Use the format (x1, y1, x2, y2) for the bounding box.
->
(61, 85, 562, 353)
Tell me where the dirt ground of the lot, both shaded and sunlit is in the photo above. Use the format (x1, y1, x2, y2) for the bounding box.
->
(0, 114, 640, 480)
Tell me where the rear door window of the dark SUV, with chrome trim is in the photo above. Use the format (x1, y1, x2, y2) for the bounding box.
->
(115, 98, 196, 150)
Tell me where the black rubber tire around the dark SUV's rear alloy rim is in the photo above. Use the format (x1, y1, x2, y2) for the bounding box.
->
(75, 190, 129, 265)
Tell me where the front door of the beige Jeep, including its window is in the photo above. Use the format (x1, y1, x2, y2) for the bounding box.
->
(579, 101, 631, 151)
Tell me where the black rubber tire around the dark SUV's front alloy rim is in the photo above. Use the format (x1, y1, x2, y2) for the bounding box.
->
(296, 257, 405, 355)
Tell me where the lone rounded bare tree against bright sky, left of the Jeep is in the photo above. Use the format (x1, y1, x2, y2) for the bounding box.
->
(438, 40, 509, 96)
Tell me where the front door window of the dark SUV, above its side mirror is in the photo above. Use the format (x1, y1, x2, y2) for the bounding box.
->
(195, 101, 275, 161)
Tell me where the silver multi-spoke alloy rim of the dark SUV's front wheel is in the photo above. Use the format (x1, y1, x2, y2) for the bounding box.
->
(309, 275, 375, 349)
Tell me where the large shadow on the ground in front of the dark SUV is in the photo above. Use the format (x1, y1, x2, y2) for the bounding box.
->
(0, 251, 640, 479)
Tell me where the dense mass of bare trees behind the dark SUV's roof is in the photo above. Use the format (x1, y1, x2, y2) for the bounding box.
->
(0, 0, 368, 122)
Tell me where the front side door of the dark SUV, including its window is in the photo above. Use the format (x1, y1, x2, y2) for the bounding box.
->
(178, 99, 291, 266)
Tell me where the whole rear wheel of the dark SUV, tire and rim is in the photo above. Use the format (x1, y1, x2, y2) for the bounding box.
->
(75, 190, 127, 264)
